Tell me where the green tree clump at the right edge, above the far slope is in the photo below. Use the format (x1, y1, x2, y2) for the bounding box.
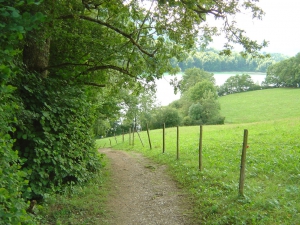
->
(265, 53, 300, 87)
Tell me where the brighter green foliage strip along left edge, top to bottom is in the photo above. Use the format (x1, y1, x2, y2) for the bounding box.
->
(0, 0, 43, 225)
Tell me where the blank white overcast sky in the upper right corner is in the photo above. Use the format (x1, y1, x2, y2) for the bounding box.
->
(211, 0, 300, 56)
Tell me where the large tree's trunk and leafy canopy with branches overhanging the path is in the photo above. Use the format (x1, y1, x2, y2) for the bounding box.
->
(24, 0, 266, 83)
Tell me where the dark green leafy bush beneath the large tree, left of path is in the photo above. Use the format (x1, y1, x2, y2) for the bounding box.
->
(13, 74, 100, 199)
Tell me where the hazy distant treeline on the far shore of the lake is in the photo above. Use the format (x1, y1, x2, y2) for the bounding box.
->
(175, 49, 288, 72)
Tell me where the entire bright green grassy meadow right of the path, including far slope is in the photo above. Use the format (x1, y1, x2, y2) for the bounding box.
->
(97, 89, 300, 225)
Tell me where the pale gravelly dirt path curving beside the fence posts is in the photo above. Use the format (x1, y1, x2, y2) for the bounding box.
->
(99, 149, 192, 225)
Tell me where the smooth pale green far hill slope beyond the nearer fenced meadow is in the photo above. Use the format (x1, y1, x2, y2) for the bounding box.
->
(219, 88, 300, 124)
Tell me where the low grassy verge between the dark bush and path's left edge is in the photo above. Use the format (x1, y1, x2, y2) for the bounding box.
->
(35, 154, 109, 225)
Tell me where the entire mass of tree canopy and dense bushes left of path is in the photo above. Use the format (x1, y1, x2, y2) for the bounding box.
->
(0, 0, 266, 224)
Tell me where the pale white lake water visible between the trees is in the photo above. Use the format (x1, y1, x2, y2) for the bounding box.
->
(155, 72, 266, 106)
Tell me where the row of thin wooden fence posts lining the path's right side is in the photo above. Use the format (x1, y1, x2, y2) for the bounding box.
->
(108, 124, 248, 196)
